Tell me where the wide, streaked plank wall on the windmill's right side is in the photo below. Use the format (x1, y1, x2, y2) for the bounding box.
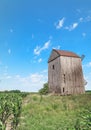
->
(60, 56, 85, 94)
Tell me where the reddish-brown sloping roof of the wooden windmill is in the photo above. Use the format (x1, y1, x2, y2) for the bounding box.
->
(53, 49, 80, 58)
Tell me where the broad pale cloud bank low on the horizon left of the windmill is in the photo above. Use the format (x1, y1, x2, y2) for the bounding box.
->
(0, 73, 48, 92)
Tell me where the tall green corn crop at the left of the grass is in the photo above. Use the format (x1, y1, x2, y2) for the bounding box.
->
(0, 90, 27, 130)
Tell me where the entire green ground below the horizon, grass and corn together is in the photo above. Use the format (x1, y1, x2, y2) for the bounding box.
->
(0, 91, 91, 130)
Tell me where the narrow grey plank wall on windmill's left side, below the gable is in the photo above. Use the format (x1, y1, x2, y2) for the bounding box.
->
(48, 57, 61, 93)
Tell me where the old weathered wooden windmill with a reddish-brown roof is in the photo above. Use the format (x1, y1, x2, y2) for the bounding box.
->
(48, 49, 85, 95)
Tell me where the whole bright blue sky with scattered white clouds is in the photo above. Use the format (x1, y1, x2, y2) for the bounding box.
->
(0, 0, 91, 91)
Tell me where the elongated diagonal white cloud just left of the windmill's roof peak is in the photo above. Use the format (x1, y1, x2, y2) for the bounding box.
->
(34, 40, 50, 55)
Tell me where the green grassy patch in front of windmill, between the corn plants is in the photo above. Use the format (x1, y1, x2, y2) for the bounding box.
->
(17, 92, 91, 130)
